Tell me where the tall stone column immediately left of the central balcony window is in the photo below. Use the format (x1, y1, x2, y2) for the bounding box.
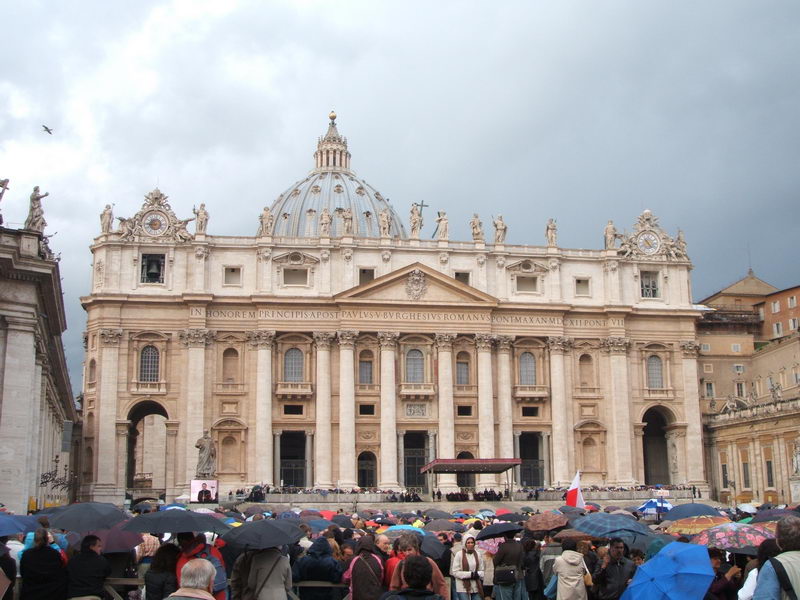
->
(378, 331, 400, 490)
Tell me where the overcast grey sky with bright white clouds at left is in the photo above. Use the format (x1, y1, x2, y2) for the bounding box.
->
(0, 0, 800, 390)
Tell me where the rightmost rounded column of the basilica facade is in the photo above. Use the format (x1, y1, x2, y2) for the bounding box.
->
(547, 337, 572, 486)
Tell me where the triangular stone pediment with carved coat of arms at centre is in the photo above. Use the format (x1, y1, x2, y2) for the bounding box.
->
(334, 263, 497, 308)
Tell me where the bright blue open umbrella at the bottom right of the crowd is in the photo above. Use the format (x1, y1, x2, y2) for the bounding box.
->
(620, 543, 714, 600)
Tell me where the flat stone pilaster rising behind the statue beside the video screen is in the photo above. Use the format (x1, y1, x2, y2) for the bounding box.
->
(178, 329, 216, 493)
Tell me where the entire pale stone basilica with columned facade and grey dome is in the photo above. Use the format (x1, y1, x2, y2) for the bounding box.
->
(81, 115, 706, 502)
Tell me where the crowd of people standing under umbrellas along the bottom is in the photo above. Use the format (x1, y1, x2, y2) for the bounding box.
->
(0, 511, 800, 600)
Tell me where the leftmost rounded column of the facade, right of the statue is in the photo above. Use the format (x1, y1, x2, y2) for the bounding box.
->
(247, 330, 279, 487)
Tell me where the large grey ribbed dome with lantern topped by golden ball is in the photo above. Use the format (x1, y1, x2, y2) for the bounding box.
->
(271, 113, 407, 238)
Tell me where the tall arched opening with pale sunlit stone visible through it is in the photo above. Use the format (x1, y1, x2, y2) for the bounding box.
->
(125, 400, 169, 490)
